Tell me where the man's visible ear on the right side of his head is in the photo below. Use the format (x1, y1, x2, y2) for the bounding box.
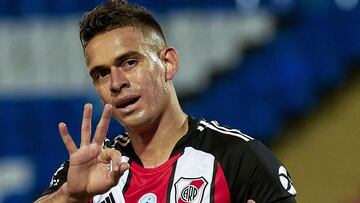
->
(160, 47, 179, 81)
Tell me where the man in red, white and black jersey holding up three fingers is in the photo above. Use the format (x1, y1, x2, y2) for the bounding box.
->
(37, 0, 296, 203)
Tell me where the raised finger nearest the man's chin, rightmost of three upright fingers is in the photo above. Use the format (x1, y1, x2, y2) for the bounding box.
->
(93, 104, 112, 146)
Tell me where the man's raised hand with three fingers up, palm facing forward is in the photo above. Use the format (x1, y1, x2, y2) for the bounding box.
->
(59, 104, 129, 202)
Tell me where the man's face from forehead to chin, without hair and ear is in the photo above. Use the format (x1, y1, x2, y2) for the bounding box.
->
(85, 27, 174, 128)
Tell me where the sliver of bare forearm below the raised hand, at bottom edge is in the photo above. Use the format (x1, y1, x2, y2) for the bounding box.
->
(34, 183, 88, 203)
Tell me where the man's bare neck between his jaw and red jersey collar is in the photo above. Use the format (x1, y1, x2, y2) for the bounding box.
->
(127, 94, 188, 168)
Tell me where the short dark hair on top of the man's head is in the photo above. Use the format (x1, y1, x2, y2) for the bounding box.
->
(79, 0, 166, 48)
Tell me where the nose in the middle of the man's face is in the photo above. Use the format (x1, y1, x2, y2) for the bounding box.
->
(110, 66, 130, 93)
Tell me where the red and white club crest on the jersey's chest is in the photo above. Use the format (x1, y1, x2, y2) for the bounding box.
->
(175, 177, 208, 203)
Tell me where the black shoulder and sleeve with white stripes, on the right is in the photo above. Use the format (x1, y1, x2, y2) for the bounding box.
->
(191, 119, 296, 202)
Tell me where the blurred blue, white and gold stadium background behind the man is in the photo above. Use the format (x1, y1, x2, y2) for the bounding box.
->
(0, 0, 360, 203)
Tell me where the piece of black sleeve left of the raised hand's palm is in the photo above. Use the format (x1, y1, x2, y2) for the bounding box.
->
(41, 161, 69, 196)
